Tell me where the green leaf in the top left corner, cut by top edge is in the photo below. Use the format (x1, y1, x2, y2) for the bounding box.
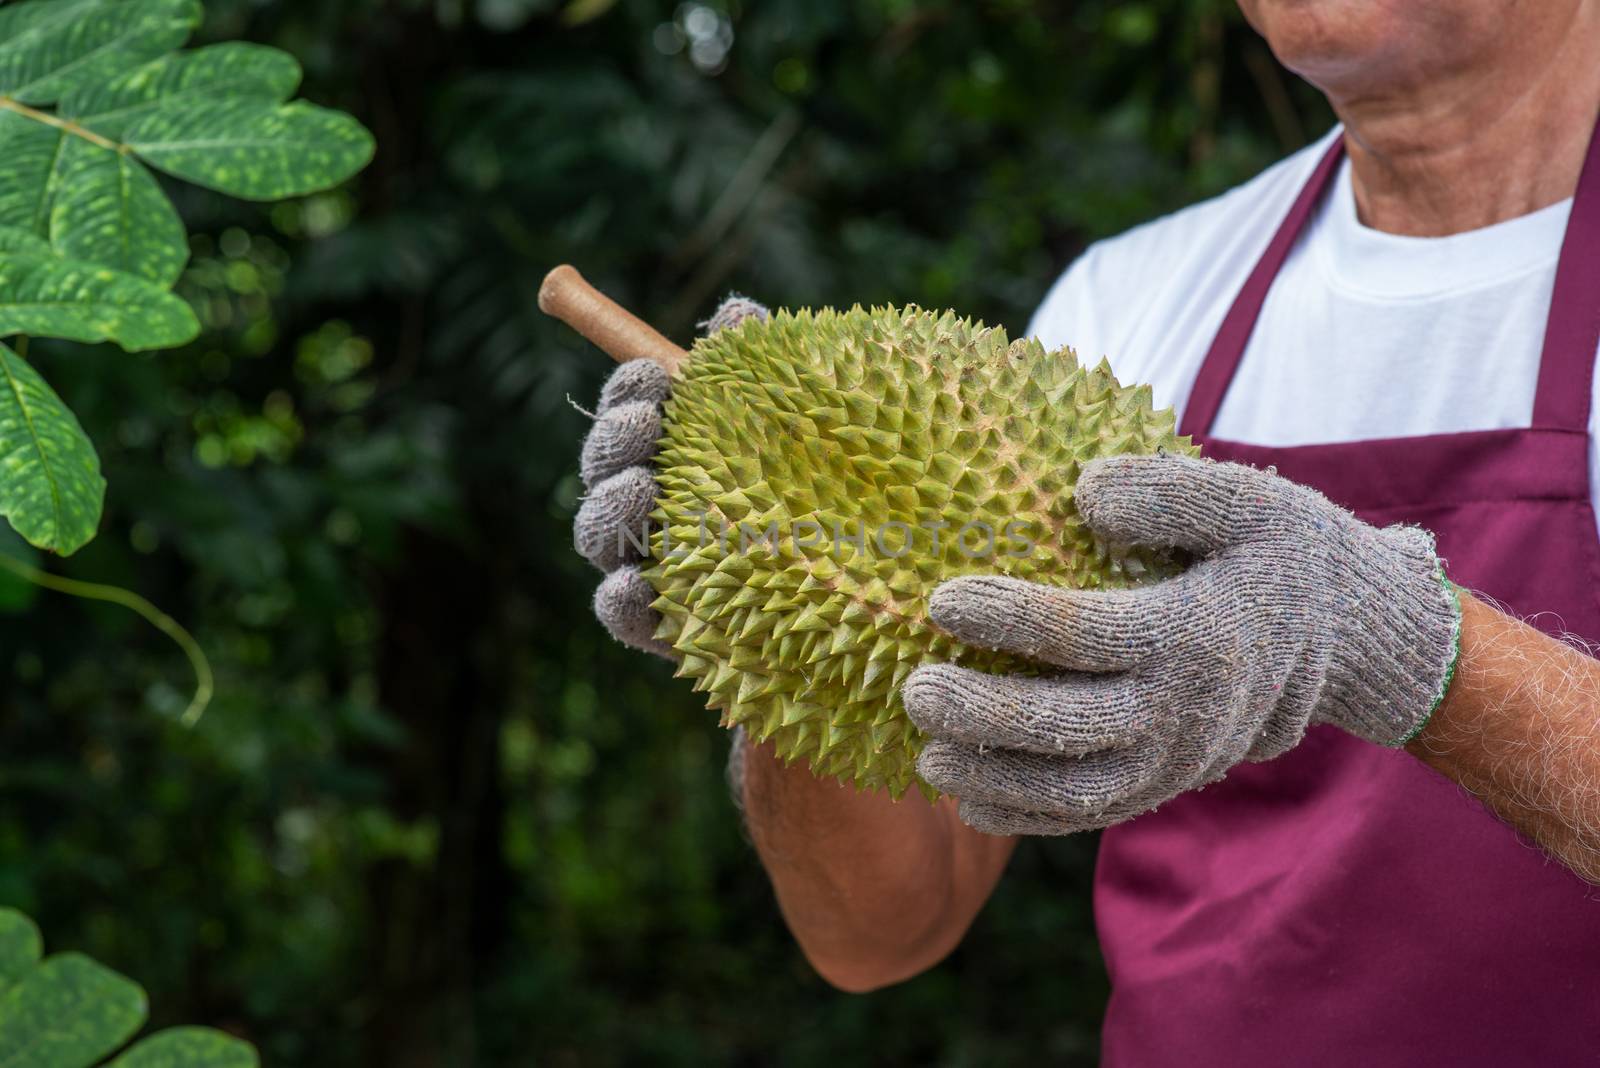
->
(0, 0, 200, 104)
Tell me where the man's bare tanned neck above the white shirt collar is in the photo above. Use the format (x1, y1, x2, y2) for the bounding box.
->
(1328, 5, 1600, 237)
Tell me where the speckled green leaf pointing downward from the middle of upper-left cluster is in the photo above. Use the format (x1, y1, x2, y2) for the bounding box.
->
(50, 137, 189, 286)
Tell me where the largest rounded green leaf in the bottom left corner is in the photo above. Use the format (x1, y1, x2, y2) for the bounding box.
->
(0, 953, 146, 1068)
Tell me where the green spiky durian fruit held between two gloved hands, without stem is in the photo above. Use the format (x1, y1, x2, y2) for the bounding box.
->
(645, 307, 1195, 796)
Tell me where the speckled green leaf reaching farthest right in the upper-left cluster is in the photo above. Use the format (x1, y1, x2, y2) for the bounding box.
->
(126, 101, 373, 200)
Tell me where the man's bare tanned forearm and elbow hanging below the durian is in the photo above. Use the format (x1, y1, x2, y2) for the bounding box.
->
(742, 745, 1016, 991)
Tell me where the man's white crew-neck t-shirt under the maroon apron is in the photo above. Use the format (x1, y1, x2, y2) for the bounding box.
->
(1029, 130, 1600, 512)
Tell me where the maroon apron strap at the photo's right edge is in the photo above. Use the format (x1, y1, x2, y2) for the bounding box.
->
(1533, 119, 1600, 433)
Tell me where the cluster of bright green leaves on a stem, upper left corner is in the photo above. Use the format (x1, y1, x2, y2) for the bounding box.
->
(0, 0, 373, 559)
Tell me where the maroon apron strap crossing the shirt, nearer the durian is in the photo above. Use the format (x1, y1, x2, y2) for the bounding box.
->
(1178, 134, 1344, 435)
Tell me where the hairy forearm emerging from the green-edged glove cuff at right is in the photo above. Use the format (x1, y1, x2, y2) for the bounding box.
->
(1406, 595, 1600, 883)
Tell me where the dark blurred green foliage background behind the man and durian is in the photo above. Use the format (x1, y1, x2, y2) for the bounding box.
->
(0, 0, 1330, 1068)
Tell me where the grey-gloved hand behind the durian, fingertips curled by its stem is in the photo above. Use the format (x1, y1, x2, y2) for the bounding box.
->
(573, 296, 768, 659)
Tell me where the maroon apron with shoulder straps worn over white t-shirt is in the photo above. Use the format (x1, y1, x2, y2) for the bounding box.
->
(1094, 119, 1600, 1068)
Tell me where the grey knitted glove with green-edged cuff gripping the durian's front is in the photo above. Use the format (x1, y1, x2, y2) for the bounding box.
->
(902, 456, 1461, 835)
